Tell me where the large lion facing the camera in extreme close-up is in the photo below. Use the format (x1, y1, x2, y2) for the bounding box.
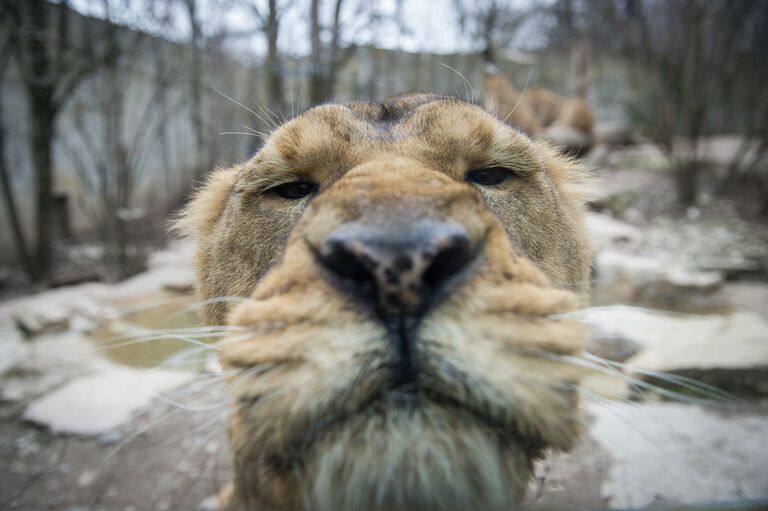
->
(179, 94, 590, 511)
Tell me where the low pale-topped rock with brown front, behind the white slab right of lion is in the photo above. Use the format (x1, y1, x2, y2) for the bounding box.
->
(595, 250, 727, 312)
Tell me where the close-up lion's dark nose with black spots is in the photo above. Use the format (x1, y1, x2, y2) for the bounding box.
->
(320, 220, 474, 317)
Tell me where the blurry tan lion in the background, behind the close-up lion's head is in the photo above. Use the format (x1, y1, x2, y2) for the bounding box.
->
(485, 73, 595, 154)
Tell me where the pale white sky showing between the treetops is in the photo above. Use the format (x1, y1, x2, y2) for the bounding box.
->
(70, 0, 544, 56)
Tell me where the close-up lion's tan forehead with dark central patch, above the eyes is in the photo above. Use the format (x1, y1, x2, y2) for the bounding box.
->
(261, 94, 530, 178)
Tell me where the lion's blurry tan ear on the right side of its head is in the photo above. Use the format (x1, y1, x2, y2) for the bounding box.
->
(535, 141, 599, 208)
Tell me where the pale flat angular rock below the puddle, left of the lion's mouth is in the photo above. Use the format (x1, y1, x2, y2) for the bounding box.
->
(24, 366, 192, 435)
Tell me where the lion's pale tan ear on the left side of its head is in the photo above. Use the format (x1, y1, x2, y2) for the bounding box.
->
(171, 166, 239, 241)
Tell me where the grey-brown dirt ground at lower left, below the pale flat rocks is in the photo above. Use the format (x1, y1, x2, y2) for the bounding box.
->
(0, 388, 231, 511)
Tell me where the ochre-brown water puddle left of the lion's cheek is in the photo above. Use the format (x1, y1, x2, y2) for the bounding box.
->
(91, 291, 213, 371)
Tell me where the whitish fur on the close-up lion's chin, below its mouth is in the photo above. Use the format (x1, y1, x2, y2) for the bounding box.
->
(299, 405, 529, 511)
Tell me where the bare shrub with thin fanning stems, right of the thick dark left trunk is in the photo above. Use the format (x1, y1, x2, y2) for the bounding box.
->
(64, 25, 182, 279)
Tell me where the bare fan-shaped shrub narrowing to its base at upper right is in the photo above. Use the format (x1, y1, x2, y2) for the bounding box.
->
(628, 0, 760, 206)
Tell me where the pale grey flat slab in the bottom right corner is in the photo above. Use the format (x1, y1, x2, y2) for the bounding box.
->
(589, 403, 768, 509)
